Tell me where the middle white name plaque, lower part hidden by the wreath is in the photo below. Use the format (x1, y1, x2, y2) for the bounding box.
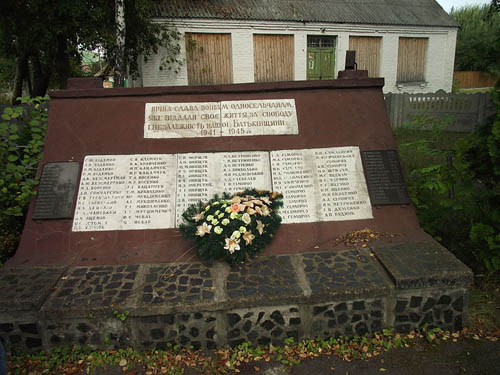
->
(176, 151, 271, 225)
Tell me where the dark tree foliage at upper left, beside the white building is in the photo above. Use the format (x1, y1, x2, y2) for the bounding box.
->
(0, 0, 180, 102)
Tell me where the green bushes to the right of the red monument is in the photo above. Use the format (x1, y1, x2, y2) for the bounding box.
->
(396, 89, 500, 276)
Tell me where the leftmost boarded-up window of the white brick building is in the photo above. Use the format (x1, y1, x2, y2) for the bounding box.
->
(186, 33, 233, 85)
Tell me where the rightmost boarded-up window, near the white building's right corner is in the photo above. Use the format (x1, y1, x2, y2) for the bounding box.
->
(397, 38, 429, 82)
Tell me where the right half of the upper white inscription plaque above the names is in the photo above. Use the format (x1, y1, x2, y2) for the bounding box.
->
(221, 99, 299, 136)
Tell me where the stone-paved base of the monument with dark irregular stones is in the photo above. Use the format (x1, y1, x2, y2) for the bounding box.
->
(0, 241, 472, 353)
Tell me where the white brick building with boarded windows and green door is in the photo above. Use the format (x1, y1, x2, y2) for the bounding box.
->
(134, 0, 458, 92)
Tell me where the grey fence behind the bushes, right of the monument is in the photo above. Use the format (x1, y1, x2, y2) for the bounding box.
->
(384, 91, 495, 132)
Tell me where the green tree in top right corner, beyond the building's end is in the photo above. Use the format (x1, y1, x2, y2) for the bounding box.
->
(450, 4, 500, 74)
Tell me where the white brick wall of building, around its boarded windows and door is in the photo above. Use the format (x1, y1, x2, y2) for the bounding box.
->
(134, 19, 457, 93)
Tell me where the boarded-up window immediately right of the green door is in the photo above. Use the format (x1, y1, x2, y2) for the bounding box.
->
(349, 36, 382, 77)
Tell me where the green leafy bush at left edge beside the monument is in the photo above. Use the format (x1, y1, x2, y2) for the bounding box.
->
(0, 97, 48, 268)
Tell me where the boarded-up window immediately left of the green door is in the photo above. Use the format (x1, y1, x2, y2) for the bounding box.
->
(253, 34, 294, 82)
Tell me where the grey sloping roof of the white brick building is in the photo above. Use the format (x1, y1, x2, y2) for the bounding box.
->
(156, 0, 458, 27)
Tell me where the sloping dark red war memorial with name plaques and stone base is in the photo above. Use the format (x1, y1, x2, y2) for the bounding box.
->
(0, 71, 472, 349)
